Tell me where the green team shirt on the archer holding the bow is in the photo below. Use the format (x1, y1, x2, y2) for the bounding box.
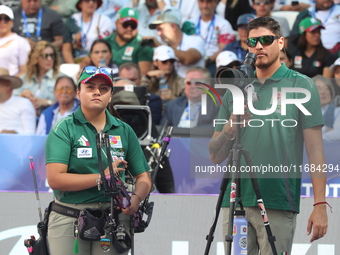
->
(45, 107, 149, 204)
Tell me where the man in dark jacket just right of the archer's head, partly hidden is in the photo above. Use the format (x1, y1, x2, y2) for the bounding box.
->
(118, 62, 163, 125)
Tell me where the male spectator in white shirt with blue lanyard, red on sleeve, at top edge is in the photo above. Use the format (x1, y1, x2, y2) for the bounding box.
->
(193, 0, 235, 76)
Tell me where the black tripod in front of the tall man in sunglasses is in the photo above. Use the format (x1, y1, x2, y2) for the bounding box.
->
(204, 115, 277, 255)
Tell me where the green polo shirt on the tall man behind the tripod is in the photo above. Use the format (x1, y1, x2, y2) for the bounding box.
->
(215, 64, 324, 212)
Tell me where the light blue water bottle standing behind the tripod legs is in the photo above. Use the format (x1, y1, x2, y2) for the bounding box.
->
(232, 210, 248, 255)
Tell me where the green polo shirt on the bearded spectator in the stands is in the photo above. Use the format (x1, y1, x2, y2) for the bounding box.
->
(104, 33, 153, 66)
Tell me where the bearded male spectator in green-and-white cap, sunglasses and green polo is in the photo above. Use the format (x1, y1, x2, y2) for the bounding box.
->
(81, 8, 153, 75)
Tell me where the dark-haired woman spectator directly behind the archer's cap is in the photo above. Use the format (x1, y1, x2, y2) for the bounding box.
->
(90, 39, 118, 74)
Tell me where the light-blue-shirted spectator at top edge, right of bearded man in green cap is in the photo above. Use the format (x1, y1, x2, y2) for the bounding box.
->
(133, 0, 162, 39)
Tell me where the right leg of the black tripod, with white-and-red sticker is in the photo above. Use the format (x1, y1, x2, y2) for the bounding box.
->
(242, 150, 277, 255)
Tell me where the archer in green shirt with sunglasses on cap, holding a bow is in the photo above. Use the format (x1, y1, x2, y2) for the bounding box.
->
(46, 66, 151, 255)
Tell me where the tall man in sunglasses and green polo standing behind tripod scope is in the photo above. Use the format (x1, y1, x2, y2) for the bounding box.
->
(209, 17, 328, 255)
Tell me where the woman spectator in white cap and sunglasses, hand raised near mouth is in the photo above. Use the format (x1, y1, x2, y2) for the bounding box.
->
(142, 45, 184, 104)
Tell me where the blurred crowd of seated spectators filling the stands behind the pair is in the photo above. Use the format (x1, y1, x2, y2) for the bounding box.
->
(0, 0, 340, 141)
